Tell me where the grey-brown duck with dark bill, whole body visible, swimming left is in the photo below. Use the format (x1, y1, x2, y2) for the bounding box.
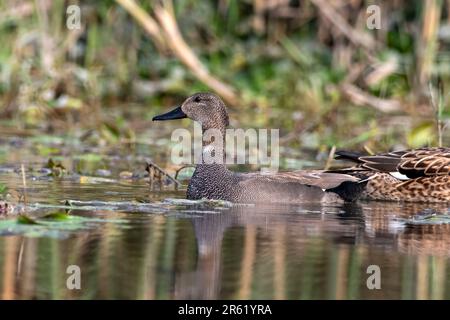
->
(153, 93, 365, 203)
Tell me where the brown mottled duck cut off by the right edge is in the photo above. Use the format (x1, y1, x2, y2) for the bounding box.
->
(329, 147, 450, 202)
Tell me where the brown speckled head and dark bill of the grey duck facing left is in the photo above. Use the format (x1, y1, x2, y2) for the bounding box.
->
(153, 93, 229, 130)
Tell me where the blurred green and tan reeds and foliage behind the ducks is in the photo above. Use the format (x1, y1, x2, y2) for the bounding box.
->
(0, 0, 450, 152)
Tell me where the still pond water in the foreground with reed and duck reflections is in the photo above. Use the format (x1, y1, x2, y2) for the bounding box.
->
(0, 134, 450, 299)
